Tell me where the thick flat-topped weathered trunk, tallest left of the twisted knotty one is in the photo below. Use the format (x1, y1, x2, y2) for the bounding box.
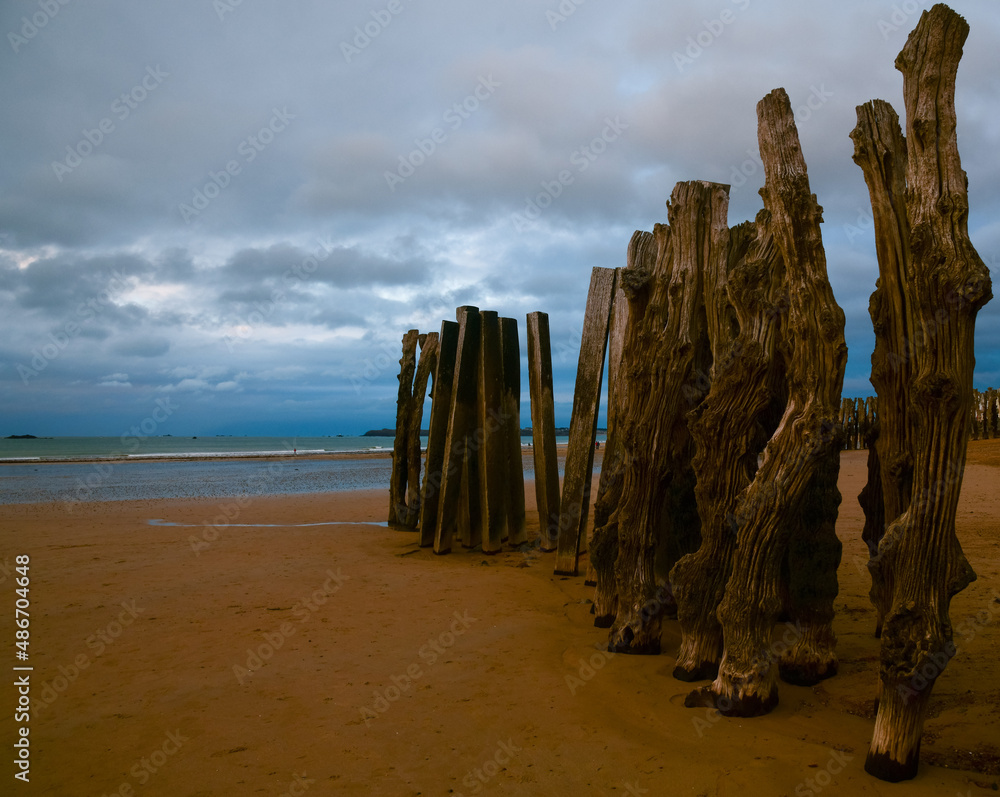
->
(608, 181, 729, 654)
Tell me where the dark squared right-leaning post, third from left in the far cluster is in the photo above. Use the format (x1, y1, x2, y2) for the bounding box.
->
(420, 321, 458, 548)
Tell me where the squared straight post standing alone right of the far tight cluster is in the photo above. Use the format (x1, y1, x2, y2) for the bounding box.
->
(528, 312, 559, 551)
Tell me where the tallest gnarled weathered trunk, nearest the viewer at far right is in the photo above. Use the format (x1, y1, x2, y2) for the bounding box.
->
(856, 4, 992, 782)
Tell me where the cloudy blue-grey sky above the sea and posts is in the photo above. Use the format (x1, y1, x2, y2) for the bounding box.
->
(0, 0, 1000, 436)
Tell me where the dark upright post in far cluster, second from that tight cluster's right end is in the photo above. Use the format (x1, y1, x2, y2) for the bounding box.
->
(473, 310, 508, 554)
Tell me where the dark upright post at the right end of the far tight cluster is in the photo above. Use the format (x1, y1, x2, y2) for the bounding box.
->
(500, 318, 528, 546)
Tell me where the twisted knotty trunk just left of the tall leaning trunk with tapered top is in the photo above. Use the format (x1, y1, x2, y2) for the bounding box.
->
(670, 215, 787, 681)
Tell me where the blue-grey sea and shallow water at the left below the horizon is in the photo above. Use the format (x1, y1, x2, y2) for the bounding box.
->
(0, 436, 584, 508)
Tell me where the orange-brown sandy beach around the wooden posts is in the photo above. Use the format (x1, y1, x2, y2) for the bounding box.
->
(0, 441, 1000, 797)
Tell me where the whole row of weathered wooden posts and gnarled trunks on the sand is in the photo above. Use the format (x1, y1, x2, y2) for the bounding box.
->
(390, 4, 997, 781)
